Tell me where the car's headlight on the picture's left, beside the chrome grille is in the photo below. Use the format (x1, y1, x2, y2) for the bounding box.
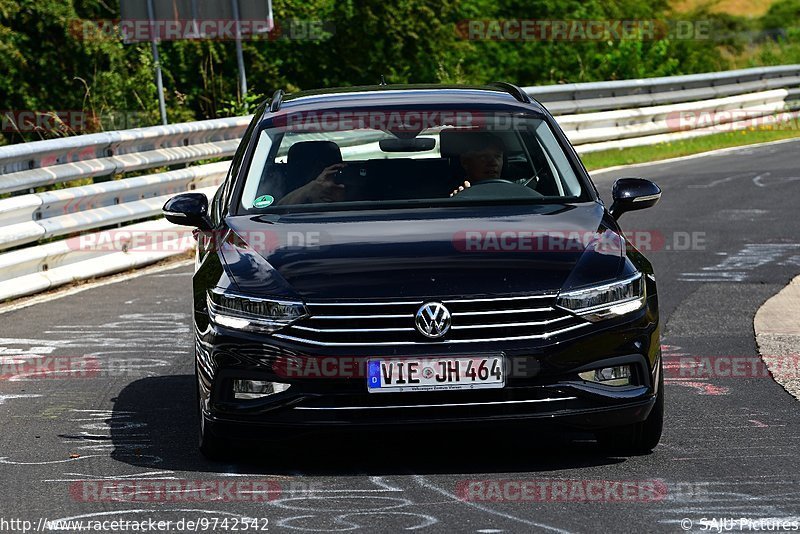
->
(206, 289, 306, 334)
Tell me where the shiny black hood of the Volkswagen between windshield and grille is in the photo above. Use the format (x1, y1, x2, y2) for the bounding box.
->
(219, 203, 624, 300)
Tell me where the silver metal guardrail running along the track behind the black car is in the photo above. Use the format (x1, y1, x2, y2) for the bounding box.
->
(0, 65, 800, 301)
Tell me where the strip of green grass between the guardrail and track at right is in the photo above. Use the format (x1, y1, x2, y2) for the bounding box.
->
(581, 123, 800, 170)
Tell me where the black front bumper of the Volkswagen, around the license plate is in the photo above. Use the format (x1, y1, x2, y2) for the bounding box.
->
(196, 306, 660, 436)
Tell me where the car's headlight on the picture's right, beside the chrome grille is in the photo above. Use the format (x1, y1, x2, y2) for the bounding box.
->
(556, 273, 646, 322)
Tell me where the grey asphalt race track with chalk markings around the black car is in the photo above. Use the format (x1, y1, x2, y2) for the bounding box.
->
(0, 142, 800, 533)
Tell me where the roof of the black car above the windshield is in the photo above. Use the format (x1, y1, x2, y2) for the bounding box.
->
(268, 84, 546, 114)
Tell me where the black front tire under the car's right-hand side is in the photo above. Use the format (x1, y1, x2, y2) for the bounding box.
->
(597, 367, 664, 455)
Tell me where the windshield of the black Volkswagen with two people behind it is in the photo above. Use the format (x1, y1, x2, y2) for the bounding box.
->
(239, 111, 585, 213)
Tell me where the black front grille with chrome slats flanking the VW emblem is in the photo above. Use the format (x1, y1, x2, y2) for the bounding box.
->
(274, 294, 589, 346)
